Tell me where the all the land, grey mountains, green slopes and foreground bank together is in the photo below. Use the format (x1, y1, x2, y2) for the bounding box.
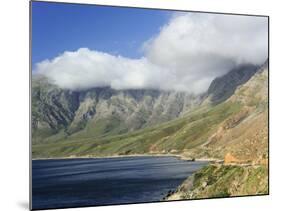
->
(32, 59, 268, 200)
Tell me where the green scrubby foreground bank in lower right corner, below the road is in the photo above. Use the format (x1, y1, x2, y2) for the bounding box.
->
(167, 165, 268, 200)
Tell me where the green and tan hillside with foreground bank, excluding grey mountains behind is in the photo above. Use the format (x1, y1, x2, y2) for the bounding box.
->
(32, 61, 268, 200)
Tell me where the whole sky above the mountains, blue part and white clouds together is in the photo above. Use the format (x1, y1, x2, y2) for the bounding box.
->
(32, 2, 268, 94)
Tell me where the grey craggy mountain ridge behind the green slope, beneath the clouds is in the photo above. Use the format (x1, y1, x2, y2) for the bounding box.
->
(32, 76, 201, 143)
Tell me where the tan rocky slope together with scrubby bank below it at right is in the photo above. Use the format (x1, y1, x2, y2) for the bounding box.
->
(165, 63, 268, 200)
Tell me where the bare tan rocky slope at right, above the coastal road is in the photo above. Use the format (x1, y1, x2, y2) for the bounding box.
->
(199, 62, 268, 163)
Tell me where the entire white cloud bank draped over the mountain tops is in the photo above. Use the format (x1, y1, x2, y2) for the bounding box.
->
(35, 13, 268, 94)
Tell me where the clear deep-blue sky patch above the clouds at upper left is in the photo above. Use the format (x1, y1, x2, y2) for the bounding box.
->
(32, 2, 171, 65)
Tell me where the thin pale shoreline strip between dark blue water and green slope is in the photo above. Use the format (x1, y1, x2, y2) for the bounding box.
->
(31, 154, 222, 162)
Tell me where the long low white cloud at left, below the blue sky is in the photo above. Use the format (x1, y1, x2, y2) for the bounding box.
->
(36, 48, 169, 89)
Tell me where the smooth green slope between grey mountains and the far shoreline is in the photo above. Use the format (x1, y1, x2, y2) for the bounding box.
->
(32, 102, 241, 158)
